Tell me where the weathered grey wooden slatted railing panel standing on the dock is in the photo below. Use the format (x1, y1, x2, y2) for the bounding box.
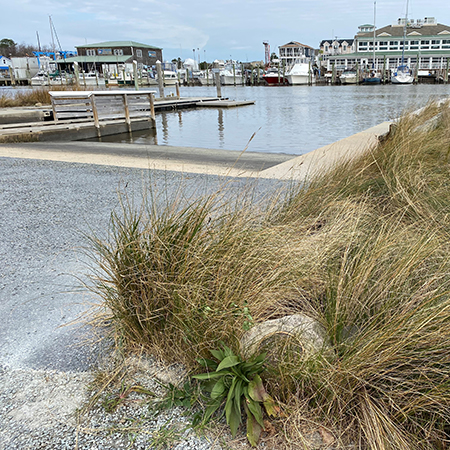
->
(50, 90, 155, 137)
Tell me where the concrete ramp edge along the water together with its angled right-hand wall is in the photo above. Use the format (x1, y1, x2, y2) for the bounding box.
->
(0, 122, 391, 181)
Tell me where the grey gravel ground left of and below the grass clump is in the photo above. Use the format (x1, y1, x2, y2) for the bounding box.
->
(0, 158, 284, 450)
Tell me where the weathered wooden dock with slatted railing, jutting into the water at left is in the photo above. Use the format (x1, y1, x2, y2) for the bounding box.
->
(0, 90, 254, 142)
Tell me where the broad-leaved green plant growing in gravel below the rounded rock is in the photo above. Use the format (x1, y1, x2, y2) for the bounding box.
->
(193, 345, 278, 446)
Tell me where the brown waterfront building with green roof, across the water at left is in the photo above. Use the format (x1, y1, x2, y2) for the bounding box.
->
(57, 41, 163, 76)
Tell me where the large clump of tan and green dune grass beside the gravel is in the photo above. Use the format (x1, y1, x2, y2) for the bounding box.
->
(87, 100, 450, 450)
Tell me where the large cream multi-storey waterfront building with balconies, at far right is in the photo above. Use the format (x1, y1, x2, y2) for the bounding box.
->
(322, 17, 450, 74)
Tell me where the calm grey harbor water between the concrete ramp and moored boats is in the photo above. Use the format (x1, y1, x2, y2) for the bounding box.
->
(96, 84, 450, 155)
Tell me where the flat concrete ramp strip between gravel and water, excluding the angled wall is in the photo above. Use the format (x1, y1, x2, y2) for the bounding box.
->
(0, 141, 295, 177)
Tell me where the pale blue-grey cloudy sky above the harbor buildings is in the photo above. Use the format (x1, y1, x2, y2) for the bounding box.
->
(0, 0, 450, 61)
